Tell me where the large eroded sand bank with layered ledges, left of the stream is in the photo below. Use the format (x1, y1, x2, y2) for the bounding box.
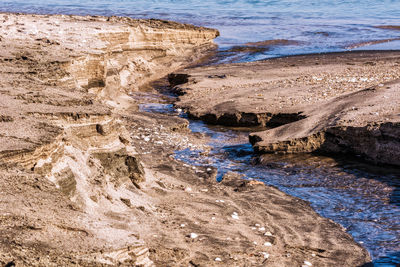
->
(0, 14, 370, 266)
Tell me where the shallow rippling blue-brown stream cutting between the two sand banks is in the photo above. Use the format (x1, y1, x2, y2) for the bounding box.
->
(139, 87, 400, 266)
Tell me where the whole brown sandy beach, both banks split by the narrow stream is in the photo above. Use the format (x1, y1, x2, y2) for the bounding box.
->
(0, 13, 388, 266)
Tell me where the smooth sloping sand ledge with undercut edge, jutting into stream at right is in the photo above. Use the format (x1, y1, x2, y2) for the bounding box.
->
(250, 82, 400, 166)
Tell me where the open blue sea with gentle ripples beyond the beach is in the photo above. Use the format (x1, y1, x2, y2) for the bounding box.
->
(0, 0, 400, 62)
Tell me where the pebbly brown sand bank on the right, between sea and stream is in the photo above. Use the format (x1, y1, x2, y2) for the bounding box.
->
(170, 51, 400, 165)
